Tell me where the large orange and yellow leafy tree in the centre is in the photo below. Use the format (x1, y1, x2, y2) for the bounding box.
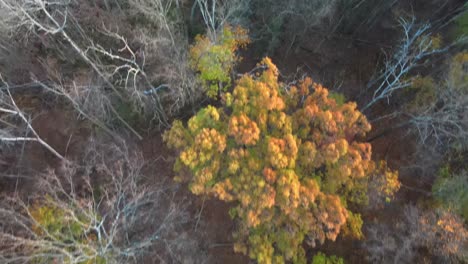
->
(164, 58, 399, 263)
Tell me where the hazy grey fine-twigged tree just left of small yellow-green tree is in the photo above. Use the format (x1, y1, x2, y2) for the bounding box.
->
(129, 0, 208, 116)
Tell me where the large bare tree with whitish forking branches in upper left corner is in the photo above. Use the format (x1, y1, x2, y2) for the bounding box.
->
(0, 0, 202, 130)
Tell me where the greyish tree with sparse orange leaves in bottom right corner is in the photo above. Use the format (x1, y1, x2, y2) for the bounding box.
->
(365, 205, 468, 263)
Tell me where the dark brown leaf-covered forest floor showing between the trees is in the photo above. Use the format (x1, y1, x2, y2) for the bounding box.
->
(0, 0, 464, 264)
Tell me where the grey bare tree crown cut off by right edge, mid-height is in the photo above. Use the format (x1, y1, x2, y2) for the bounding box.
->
(407, 52, 468, 148)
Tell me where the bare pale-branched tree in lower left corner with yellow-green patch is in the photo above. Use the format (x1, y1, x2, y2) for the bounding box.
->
(0, 139, 192, 263)
